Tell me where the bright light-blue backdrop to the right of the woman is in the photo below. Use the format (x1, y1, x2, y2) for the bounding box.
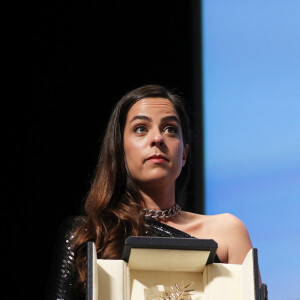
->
(202, 0, 300, 300)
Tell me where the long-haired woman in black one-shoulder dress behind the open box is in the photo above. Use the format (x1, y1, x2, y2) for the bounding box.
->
(46, 85, 262, 299)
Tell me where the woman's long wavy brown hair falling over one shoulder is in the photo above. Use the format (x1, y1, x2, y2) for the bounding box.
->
(74, 85, 190, 292)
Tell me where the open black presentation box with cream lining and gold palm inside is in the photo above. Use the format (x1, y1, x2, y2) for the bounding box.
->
(87, 237, 259, 300)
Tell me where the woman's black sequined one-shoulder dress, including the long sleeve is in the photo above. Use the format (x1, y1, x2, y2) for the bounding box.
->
(44, 216, 219, 300)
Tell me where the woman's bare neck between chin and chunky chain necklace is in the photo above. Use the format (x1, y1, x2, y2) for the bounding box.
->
(140, 186, 175, 210)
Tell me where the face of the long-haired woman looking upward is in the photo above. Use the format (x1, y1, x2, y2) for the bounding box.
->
(124, 98, 188, 187)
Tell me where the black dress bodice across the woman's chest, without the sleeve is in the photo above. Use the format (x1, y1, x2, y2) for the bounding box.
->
(145, 218, 220, 263)
